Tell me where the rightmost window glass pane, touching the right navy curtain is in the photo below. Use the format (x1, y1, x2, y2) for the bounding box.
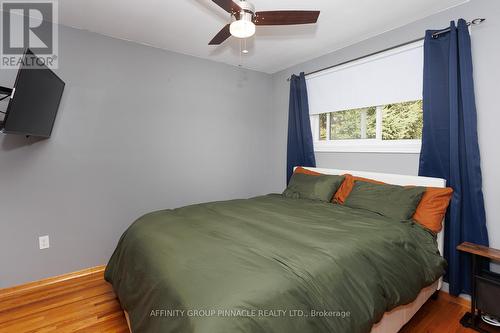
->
(382, 100, 423, 140)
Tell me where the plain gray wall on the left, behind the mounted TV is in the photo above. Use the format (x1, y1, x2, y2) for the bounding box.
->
(0, 27, 281, 288)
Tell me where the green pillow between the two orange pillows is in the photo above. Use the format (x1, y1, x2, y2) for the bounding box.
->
(344, 181, 426, 220)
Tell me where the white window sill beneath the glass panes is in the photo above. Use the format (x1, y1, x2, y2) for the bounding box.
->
(314, 140, 422, 154)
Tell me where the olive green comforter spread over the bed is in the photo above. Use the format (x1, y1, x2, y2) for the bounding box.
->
(105, 195, 446, 333)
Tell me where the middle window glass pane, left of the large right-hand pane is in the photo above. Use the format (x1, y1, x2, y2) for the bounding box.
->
(330, 108, 376, 140)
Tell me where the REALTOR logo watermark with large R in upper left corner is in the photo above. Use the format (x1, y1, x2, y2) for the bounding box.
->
(0, 0, 59, 69)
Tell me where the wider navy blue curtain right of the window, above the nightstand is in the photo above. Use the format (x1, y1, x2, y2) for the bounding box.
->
(419, 19, 488, 295)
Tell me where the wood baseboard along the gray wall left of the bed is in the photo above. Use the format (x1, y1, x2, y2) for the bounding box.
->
(0, 265, 106, 298)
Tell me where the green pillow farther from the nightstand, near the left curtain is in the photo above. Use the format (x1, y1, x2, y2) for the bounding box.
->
(283, 173, 344, 202)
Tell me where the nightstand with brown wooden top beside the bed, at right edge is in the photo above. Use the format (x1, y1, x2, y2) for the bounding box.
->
(457, 242, 500, 333)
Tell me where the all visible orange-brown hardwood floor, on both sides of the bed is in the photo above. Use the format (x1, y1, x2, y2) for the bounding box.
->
(0, 267, 500, 333)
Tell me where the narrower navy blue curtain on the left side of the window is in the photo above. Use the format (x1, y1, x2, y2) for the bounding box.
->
(286, 73, 316, 183)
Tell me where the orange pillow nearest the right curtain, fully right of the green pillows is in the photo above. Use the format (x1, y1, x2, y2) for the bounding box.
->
(413, 187, 453, 234)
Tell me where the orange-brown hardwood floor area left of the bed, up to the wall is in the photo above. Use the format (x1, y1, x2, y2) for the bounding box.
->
(0, 269, 128, 333)
